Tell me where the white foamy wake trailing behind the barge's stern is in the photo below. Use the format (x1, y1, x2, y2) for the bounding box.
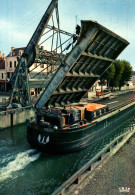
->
(0, 149, 41, 182)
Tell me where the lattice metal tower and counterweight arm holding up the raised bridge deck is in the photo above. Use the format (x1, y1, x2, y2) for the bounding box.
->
(9, 0, 76, 106)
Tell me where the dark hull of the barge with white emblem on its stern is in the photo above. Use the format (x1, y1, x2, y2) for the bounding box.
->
(27, 103, 135, 153)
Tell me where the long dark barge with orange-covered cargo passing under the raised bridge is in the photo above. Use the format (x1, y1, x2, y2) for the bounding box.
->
(27, 102, 135, 153)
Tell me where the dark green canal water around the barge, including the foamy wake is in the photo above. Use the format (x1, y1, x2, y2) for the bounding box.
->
(0, 117, 135, 195)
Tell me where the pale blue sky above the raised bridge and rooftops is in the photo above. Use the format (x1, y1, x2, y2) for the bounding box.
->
(0, 0, 135, 70)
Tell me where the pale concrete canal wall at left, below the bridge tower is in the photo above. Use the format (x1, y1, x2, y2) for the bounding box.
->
(0, 106, 35, 129)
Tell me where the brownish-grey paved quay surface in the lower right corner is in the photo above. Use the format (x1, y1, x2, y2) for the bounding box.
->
(74, 137, 135, 195)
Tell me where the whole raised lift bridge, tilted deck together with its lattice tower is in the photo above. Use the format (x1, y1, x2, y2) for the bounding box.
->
(9, 0, 129, 109)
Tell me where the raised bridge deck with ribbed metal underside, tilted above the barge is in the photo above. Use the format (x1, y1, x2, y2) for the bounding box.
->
(36, 20, 129, 108)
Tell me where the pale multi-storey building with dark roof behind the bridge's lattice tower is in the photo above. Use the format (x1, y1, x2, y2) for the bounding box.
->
(0, 47, 48, 95)
